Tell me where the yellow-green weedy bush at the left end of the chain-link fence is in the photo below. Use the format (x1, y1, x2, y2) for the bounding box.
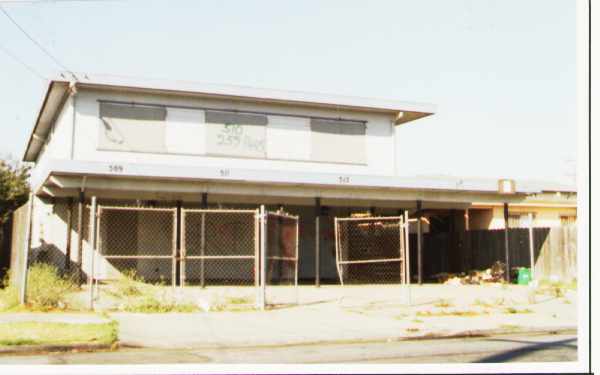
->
(27, 263, 78, 311)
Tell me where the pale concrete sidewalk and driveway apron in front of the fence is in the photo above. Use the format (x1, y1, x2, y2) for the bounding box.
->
(110, 286, 577, 348)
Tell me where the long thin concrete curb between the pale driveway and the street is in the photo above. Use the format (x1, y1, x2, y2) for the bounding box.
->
(120, 326, 577, 349)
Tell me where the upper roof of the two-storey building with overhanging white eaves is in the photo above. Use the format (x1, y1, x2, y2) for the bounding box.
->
(23, 73, 436, 162)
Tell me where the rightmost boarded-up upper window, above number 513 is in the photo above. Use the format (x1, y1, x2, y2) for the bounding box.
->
(310, 119, 366, 164)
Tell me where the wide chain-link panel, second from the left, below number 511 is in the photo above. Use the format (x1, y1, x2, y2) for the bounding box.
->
(181, 209, 259, 287)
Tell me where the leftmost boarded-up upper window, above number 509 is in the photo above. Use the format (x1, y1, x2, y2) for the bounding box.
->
(98, 103, 167, 153)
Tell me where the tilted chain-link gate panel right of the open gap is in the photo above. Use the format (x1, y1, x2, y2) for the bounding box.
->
(335, 217, 407, 285)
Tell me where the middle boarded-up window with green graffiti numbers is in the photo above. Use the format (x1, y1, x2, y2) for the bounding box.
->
(205, 111, 268, 158)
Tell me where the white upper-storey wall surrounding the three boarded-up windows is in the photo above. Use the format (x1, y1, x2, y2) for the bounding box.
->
(65, 90, 394, 175)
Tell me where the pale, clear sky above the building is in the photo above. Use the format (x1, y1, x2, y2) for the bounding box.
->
(0, 0, 577, 182)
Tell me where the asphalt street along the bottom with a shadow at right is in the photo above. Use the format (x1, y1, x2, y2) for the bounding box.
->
(0, 334, 577, 364)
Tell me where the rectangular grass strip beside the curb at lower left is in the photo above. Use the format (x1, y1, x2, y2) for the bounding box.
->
(0, 322, 118, 345)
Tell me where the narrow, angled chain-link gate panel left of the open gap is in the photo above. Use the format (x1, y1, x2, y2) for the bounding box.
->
(265, 212, 299, 305)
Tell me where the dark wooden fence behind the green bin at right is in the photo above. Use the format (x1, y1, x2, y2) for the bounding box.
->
(410, 225, 577, 280)
